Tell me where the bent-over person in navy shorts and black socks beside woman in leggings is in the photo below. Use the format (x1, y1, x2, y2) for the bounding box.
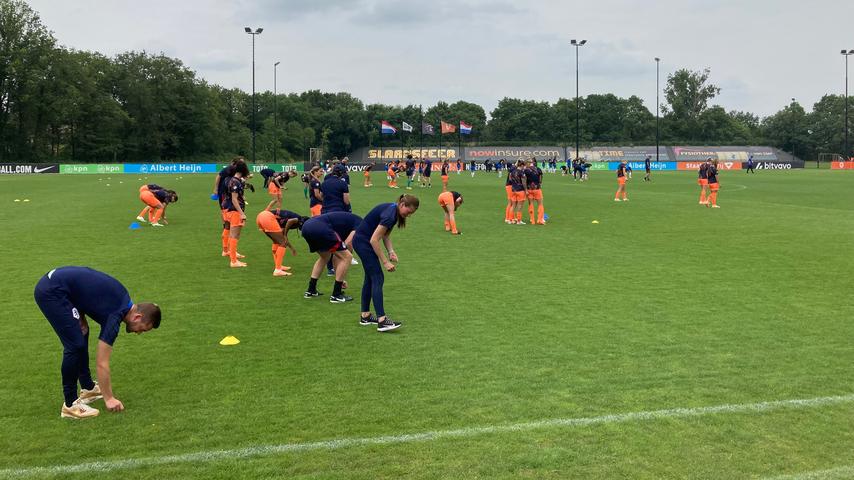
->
(302, 211, 362, 303)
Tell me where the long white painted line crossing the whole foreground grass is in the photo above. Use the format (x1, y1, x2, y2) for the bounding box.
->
(0, 394, 854, 478)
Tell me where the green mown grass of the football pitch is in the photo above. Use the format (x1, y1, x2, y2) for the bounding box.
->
(0, 170, 854, 479)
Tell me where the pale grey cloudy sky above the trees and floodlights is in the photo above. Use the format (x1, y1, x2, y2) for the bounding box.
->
(28, 0, 854, 116)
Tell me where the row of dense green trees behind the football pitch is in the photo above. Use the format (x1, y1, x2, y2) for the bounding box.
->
(0, 0, 845, 162)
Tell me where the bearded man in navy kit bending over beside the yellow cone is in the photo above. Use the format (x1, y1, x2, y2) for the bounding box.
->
(34, 267, 160, 419)
